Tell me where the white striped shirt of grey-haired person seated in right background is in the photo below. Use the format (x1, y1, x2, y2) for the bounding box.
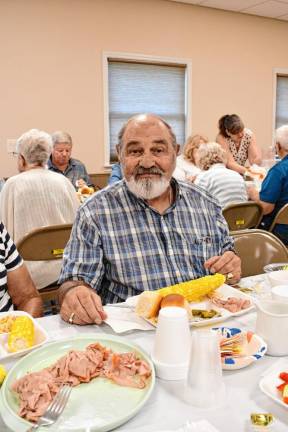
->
(195, 163, 248, 207)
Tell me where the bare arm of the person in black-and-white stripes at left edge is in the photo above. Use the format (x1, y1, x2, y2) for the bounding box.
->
(7, 264, 43, 318)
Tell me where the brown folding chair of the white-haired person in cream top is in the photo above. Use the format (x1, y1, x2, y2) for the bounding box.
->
(16, 224, 72, 313)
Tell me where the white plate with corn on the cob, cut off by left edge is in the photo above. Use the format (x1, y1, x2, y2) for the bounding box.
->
(0, 311, 48, 360)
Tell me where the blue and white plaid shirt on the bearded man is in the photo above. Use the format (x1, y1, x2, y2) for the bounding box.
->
(59, 179, 234, 304)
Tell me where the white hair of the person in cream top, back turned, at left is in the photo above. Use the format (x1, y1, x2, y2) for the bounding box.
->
(16, 129, 52, 166)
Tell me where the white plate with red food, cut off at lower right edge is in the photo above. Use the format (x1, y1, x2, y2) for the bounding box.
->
(259, 360, 288, 409)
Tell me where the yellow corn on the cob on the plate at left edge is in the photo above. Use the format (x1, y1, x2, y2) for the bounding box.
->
(8, 316, 34, 352)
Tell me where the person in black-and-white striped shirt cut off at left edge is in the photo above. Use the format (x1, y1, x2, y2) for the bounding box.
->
(0, 222, 43, 317)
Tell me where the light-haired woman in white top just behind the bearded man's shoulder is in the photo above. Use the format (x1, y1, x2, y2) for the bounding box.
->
(173, 135, 208, 181)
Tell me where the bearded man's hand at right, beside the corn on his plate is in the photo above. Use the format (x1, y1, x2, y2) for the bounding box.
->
(204, 251, 241, 285)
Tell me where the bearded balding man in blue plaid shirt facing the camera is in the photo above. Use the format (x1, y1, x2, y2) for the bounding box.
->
(59, 114, 241, 324)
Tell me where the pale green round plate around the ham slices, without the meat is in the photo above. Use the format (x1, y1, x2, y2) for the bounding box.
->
(0, 333, 155, 432)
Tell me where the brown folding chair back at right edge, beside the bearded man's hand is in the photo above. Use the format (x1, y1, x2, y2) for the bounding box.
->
(230, 229, 288, 277)
